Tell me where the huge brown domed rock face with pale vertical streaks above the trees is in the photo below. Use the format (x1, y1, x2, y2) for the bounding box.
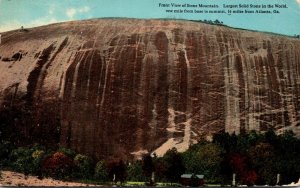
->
(0, 19, 300, 158)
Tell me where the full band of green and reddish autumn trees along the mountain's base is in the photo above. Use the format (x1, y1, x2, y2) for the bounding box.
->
(0, 131, 300, 185)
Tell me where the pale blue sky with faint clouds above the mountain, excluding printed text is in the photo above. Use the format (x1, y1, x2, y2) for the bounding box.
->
(0, 0, 300, 35)
